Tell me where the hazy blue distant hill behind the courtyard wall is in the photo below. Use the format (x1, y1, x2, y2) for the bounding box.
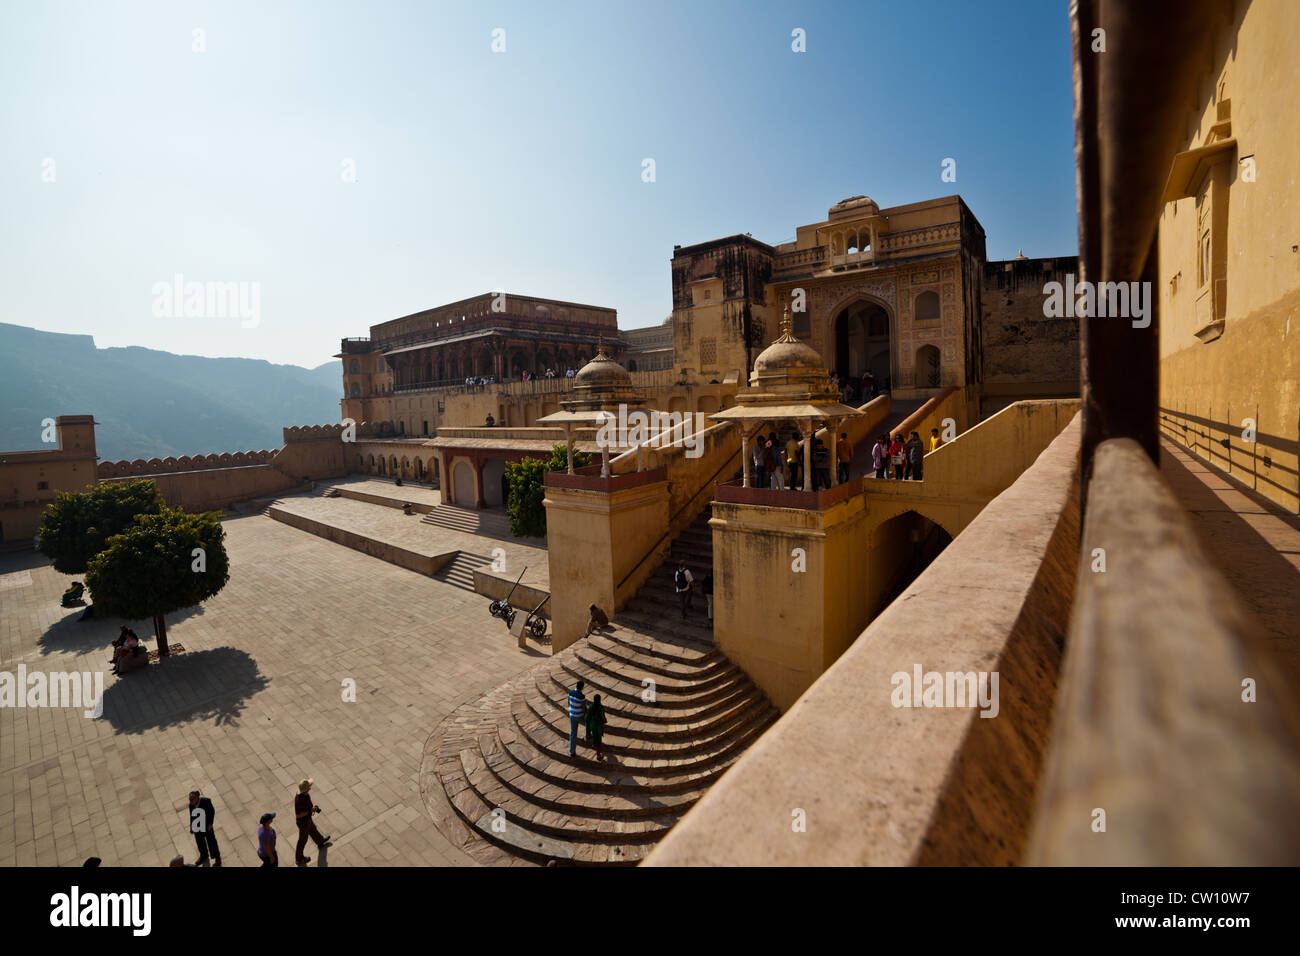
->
(0, 323, 343, 462)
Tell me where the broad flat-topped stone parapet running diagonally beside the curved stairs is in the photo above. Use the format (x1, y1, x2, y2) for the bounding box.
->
(647, 416, 1087, 866)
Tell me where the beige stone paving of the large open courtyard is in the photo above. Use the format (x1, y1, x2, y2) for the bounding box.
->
(0, 515, 545, 866)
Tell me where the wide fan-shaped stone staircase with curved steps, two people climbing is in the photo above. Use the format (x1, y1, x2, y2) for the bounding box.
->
(420, 507, 779, 865)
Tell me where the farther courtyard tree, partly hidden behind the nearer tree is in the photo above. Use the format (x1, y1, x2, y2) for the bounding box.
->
(38, 479, 165, 575)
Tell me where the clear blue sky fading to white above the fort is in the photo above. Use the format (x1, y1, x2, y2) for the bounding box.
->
(0, 0, 1078, 367)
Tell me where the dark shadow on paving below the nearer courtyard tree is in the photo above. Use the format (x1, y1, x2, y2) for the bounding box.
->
(103, 646, 270, 734)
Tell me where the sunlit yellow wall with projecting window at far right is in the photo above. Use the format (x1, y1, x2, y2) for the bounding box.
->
(1156, 0, 1300, 514)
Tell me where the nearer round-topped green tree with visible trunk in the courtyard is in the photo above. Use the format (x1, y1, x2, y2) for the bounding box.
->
(86, 507, 230, 657)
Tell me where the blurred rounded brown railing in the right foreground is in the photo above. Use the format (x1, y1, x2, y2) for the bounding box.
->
(1024, 438, 1300, 866)
